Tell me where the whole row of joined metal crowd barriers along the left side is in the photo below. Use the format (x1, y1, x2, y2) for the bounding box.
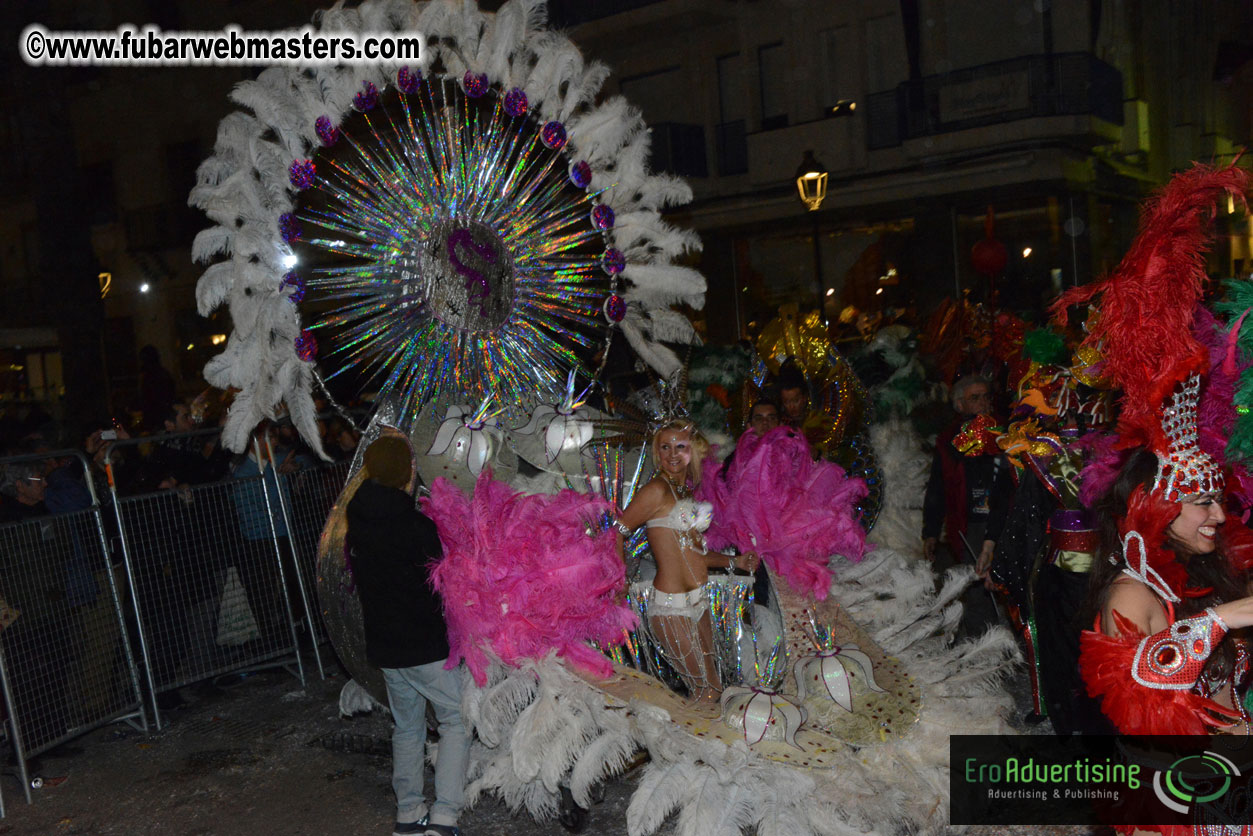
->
(0, 430, 350, 802)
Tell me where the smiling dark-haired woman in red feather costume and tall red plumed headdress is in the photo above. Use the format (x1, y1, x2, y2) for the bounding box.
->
(1055, 160, 1253, 836)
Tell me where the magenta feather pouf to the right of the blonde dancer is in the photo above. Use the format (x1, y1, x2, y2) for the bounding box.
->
(697, 426, 866, 600)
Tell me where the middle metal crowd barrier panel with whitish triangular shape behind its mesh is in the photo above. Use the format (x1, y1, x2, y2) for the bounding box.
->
(105, 430, 321, 728)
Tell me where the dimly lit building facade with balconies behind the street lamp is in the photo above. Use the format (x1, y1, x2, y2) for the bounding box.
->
(556, 0, 1253, 342)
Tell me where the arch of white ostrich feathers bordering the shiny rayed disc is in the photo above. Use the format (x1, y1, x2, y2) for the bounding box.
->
(189, 0, 704, 450)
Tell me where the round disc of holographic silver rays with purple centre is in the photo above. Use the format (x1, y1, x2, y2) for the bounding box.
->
(297, 79, 610, 420)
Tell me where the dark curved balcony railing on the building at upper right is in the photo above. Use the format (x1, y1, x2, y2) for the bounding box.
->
(866, 53, 1123, 150)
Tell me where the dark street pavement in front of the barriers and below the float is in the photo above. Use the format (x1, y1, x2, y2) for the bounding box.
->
(0, 651, 1089, 836)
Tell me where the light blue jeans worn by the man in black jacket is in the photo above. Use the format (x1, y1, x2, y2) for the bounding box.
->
(382, 659, 470, 825)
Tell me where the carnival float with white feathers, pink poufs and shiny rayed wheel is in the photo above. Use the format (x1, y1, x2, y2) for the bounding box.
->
(192, 0, 1017, 836)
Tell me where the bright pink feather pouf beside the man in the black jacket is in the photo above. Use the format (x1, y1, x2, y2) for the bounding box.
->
(422, 471, 635, 686)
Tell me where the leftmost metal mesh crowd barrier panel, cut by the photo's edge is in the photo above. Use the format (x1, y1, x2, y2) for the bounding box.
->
(0, 450, 148, 810)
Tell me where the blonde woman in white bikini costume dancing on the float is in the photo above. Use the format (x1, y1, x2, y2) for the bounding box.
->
(616, 419, 758, 704)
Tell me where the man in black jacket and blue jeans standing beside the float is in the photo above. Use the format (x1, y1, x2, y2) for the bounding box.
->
(348, 436, 470, 836)
